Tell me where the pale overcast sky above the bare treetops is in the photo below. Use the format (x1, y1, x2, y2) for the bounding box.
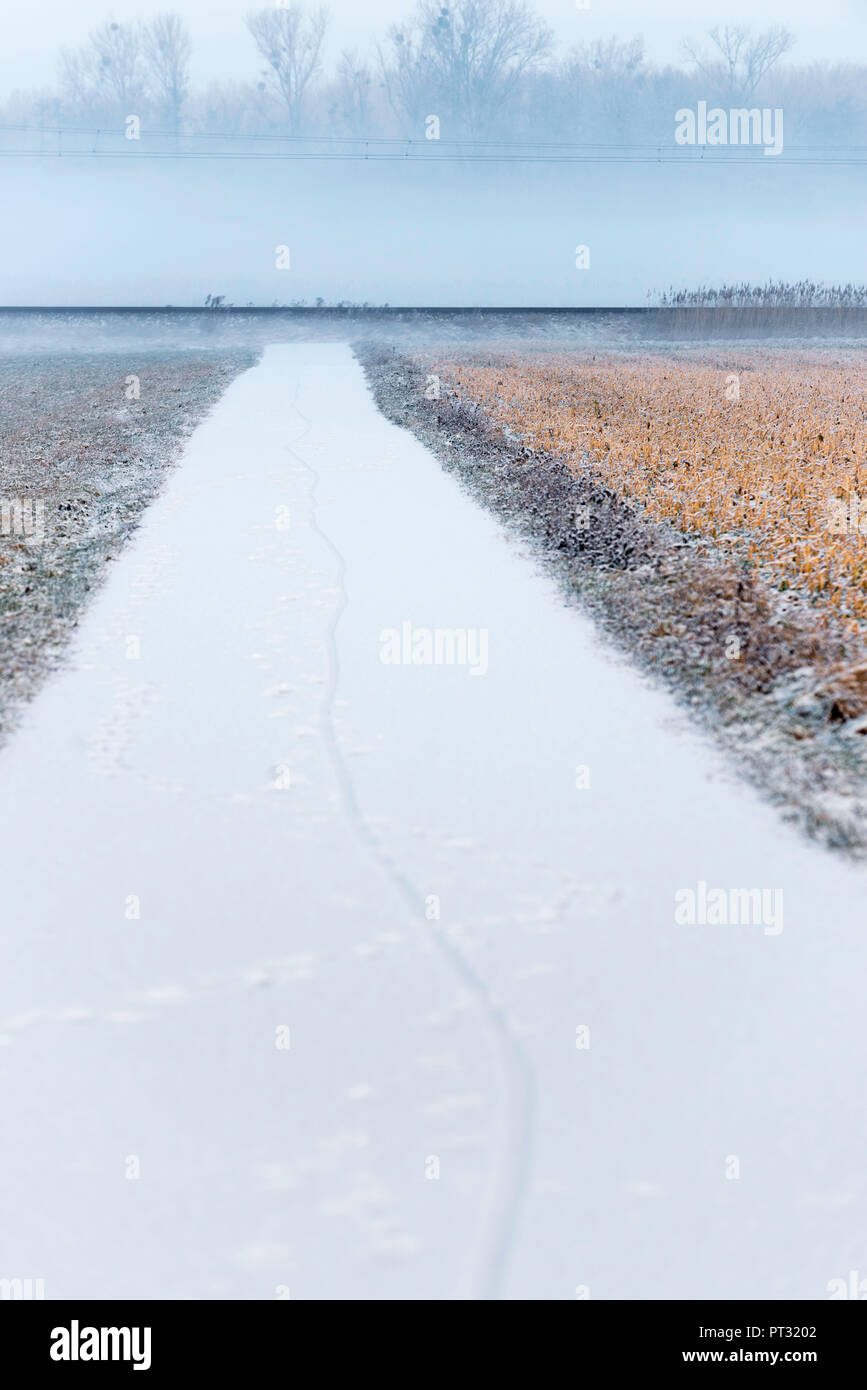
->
(0, 0, 867, 100)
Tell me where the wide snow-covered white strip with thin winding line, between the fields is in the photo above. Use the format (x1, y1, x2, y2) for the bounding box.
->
(0, 345, 867, 1298)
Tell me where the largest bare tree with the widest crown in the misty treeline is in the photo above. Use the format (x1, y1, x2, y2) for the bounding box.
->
(381, 0, 553, 135)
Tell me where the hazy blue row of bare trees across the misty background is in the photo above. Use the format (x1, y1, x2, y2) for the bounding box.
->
(7, 0, 867, 139)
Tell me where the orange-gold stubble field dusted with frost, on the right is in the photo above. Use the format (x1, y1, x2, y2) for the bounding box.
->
(434, 350, 867, 623)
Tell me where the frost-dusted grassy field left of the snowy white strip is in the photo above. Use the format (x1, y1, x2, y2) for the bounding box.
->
(0, 346, 256, 734)
